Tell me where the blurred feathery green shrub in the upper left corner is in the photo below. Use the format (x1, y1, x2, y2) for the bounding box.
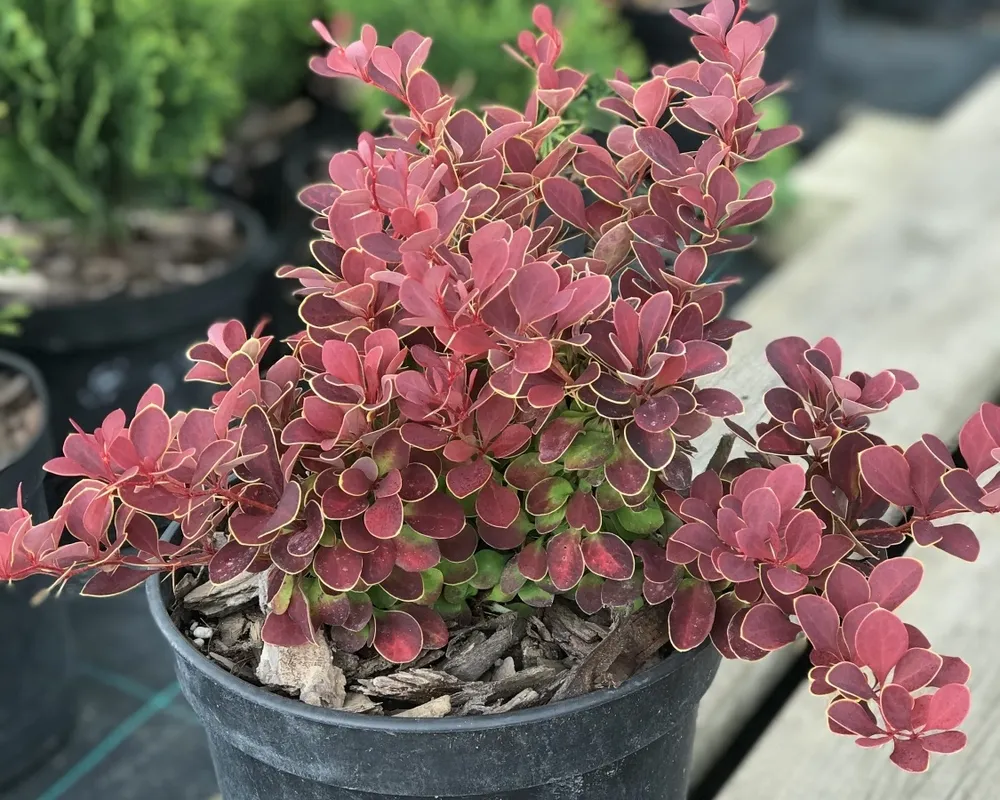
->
(0, 0, 246, 226)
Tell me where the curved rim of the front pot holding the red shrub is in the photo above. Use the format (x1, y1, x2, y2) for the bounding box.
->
(145, 560, 712, 734)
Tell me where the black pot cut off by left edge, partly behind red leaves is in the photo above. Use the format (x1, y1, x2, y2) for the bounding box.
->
(0, 351, 76, 788)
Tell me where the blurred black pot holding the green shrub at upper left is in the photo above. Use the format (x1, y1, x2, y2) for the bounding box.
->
(0, 200, 274, 439)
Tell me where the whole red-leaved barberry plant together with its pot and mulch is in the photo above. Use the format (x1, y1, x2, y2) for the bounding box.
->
(0, 0, 1000, 800)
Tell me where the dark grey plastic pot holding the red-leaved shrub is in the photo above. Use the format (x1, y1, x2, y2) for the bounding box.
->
(146, 578, 719, 800)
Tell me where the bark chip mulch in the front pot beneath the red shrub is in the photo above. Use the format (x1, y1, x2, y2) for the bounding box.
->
(170, 573, 669, 718)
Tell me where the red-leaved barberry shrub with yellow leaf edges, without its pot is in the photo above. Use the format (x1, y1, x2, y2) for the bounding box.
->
(0, 0, 1000, 770)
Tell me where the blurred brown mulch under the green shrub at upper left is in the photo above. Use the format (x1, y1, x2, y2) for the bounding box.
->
(0, 208, 242, 308)
